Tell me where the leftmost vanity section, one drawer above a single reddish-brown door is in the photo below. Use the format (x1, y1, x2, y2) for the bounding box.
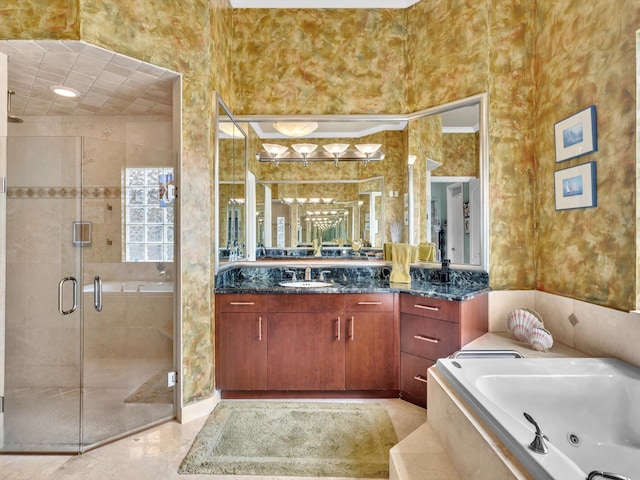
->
(215, 294, 267, 391)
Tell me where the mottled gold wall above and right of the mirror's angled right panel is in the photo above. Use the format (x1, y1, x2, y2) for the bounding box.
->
(407, 0, 536, 290)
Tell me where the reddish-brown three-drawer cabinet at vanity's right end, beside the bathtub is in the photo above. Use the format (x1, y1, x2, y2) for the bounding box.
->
(400, 294, 489, 407)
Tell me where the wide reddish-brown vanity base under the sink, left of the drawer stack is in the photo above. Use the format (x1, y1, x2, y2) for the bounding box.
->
(216, 293, 400, 396)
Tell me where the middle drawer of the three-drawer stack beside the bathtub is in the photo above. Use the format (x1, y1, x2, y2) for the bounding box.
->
(400, 313, 460, 360)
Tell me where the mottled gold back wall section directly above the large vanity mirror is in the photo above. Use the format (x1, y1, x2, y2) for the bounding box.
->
(233, 8, 407, 114)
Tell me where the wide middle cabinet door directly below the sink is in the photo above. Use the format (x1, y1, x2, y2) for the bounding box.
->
(267, 313, 344, 390)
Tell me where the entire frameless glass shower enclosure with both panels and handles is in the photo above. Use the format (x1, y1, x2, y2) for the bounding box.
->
(0, 136, 175, 453)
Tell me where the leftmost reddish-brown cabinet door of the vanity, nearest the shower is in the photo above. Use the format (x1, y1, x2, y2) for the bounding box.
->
(216, 313, 267, 390)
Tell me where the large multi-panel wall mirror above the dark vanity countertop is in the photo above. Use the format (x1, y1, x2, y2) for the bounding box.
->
(216, 94, 489, 271)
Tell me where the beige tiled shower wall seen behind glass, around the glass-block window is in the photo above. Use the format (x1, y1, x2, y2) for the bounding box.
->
(6, 117, 174, 386)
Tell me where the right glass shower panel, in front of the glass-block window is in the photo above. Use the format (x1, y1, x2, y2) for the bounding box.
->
(82, 137, 175, 449)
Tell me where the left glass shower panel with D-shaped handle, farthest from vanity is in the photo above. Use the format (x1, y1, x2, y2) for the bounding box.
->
(0, 136, 83, 453)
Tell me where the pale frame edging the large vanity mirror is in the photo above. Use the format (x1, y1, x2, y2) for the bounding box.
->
(221, 92, 490, 272)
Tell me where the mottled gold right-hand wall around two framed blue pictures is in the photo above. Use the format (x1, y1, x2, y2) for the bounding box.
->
(535, 0, 640, 310)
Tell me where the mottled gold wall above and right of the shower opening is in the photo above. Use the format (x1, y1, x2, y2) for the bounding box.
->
(0, 0, 233, 404)
